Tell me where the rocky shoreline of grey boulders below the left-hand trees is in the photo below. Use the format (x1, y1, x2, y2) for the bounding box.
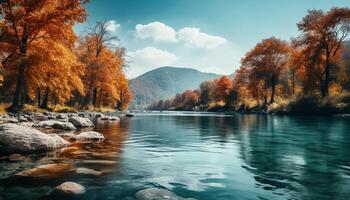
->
(0, 112, 123, 157)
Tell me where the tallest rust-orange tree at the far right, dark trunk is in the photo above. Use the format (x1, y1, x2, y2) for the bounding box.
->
(298, 8, 350, 96)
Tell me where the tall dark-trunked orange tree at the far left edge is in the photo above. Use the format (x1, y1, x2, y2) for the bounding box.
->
(0, 0, 87, 110)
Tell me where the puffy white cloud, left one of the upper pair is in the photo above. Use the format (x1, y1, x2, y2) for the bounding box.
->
(135, 22, 177, 42)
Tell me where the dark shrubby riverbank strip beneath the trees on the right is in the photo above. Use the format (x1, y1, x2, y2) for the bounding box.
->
(152, 94, 350, 118)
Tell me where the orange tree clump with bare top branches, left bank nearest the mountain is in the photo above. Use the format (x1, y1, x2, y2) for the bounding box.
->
(77, 22, 131, 109)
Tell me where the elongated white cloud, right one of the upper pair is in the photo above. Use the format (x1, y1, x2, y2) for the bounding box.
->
(178, 27, 227, 49)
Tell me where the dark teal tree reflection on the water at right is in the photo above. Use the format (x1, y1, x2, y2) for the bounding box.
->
(232, 115, 350, 199)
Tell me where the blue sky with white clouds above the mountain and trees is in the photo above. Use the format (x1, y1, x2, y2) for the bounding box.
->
(76, 0, 350, 78)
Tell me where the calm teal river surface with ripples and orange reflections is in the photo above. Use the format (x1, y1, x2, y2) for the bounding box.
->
(0, 112, 350, 200)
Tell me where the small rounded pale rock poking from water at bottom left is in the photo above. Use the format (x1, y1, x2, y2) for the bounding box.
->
(51, 182, 86, 196)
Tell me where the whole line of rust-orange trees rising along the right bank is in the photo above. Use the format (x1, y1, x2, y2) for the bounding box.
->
(149, 7, 350, 110)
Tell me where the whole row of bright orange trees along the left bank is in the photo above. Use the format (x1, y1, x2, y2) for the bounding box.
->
(0, 0, 132, 111)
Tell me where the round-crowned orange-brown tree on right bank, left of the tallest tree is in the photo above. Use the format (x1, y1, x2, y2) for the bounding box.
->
(242, 37, 288, 103)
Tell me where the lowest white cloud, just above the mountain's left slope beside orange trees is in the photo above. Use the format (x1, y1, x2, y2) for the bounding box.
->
(127, 47, 178, 78)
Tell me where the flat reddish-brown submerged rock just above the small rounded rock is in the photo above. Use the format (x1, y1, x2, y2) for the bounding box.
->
(15, 164, 76, 179)
